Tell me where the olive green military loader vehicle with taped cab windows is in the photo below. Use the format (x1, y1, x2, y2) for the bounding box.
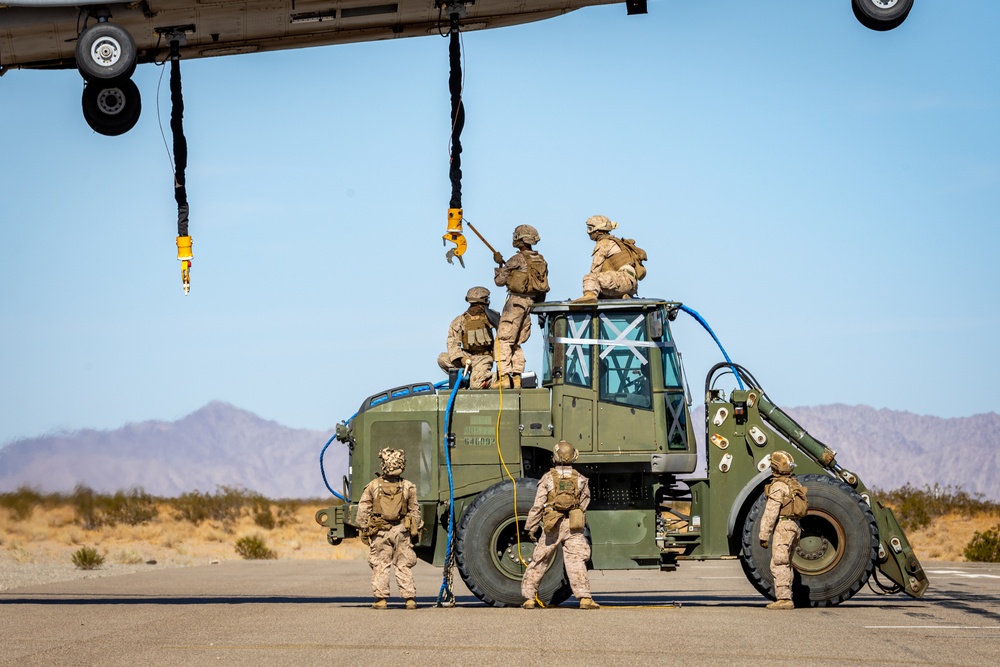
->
(316, 299, 927, 606)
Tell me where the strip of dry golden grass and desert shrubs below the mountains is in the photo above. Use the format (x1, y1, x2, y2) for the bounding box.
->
(0, 487, 1000, 566)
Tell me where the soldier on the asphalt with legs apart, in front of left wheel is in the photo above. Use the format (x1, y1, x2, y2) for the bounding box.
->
(521, 440, 601, 609)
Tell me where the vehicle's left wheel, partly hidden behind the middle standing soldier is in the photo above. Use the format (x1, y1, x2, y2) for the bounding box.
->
(455, 479, 571, 607)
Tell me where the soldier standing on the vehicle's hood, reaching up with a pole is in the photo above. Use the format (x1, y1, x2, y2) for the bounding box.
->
(493, 225, 549, 389)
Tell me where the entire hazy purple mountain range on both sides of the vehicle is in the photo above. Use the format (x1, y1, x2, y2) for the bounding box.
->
(0, 402, 1000, 500)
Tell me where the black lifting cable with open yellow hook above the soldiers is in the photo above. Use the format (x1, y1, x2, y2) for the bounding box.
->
(439, 0, 467, 269)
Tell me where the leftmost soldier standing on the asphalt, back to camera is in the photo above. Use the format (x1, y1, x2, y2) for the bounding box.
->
(358, 449, 423, 609)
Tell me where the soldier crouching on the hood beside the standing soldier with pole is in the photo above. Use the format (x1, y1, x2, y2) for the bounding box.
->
(438, 287, 500, 389)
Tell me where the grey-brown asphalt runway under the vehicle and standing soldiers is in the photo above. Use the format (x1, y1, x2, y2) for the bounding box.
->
(0, 561, 1000, 667)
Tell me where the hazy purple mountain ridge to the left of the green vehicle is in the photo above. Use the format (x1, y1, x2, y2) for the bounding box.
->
(0, 402, 347, 498)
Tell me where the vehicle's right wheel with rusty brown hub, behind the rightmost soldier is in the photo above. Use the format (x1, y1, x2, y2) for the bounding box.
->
(740, 475, 878, 607)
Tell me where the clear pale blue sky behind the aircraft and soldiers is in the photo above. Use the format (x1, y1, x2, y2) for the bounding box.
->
(0, 0, 1000, 444)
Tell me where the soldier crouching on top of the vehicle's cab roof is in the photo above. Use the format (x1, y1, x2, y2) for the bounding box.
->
(573, 215, 646, 303)
